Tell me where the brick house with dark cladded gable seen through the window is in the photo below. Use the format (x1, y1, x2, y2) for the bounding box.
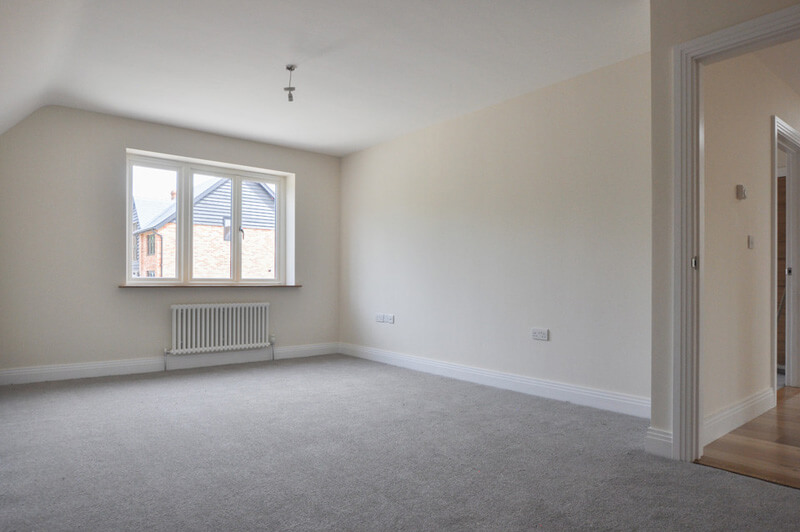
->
(133, 178, 275, 279)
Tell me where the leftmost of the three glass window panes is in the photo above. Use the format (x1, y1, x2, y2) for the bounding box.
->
(131, 165, 178, 279)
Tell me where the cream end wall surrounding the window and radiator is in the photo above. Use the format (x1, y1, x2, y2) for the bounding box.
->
(0, 107, 340, 369)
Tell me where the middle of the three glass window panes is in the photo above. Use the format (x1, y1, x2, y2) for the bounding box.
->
(192, 174, 232, 279)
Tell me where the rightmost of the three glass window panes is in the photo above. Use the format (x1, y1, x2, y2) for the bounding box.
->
(242, 180, 276, 279)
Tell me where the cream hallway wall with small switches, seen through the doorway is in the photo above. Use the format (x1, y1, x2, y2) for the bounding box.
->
(700, 54, 800, 417)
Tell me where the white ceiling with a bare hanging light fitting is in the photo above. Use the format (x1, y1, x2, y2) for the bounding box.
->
(0, 0, 650, 155)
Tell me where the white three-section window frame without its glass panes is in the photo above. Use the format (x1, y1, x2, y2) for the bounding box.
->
(125, 149, 295, 286)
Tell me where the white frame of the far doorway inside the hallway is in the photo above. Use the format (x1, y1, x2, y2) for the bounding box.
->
(772, 116, 800, 389)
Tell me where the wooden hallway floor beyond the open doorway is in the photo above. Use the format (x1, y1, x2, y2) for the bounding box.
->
(697, 388, 800, 488)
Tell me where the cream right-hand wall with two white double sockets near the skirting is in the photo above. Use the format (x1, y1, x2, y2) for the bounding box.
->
(340, 55, 651, 397)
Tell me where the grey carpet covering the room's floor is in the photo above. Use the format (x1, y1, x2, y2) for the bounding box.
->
(0, 356, 800, 531)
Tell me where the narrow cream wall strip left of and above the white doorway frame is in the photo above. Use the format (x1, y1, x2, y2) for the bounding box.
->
(650, 0, 800, 432)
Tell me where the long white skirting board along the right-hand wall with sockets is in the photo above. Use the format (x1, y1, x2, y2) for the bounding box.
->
(339, 344, 650, 418)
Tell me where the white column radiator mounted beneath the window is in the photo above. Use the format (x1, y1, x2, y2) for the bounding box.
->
(168, 303, 269, 355)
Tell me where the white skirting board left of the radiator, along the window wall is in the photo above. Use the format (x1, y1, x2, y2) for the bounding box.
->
(0, 356, 164, 385)
